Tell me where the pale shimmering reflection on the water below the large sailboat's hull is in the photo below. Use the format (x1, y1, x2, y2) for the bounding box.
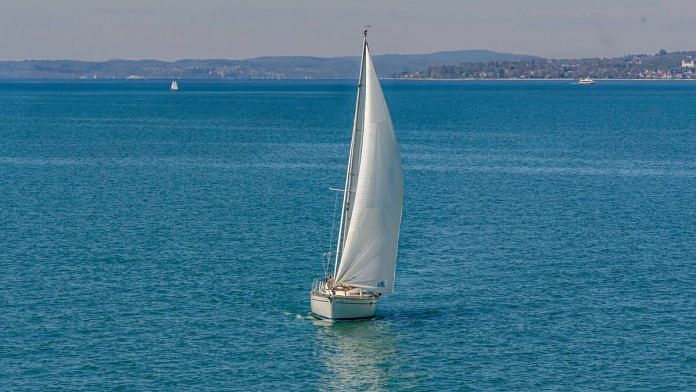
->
(314, 320, 400, 391)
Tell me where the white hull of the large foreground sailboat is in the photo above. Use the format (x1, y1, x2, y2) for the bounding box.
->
(311, 292, 379, 320)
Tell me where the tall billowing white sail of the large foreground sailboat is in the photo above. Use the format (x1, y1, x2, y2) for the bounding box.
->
(334, 44, 403, 294)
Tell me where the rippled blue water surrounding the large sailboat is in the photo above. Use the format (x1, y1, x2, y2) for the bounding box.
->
(0, 81, 696, 391)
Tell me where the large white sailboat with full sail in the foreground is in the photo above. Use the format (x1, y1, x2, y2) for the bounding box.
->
(310, 30, 404, 320)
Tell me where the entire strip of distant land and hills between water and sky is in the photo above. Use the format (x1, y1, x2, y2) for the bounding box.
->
(0, 50, 696, 80)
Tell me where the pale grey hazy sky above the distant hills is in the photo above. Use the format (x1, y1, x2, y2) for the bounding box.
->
(0, 0, 696, 60)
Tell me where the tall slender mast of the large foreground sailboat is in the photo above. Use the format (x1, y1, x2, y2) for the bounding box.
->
(332, 30, 369, 285)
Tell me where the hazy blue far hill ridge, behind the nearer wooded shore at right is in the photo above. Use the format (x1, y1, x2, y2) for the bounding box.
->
(0, 50, 540, 79)
